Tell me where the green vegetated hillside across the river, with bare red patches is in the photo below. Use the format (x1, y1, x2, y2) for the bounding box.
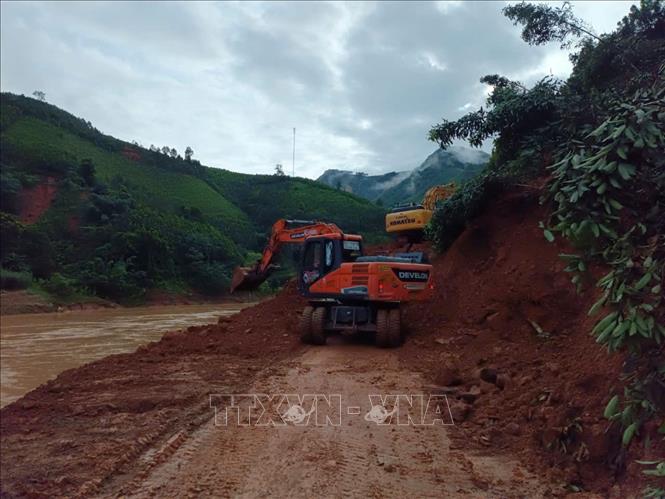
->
(0, 93, 383, 301)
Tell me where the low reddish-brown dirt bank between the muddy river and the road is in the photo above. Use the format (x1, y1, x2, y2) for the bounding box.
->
(0, 285, 304, 497)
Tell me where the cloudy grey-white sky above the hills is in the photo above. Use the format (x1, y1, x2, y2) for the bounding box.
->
(0, 1, 632, 178)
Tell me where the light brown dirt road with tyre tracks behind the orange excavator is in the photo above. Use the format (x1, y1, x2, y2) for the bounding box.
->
(100, 339, 547, 497)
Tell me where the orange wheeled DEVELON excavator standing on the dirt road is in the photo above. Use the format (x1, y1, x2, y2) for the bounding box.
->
(232, 220, 434, 347)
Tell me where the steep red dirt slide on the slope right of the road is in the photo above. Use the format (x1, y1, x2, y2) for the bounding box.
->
(400, 191, 663, 493)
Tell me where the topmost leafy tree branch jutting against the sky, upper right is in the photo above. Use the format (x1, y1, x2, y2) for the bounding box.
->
(502, 2, 600, 48)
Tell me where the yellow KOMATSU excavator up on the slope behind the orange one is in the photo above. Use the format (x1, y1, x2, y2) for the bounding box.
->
(386, 182, 457, 243)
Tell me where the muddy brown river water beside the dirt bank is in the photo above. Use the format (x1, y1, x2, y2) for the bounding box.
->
(0, 303, 251, 406)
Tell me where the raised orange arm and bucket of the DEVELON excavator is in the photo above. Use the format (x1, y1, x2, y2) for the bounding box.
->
(231, 219, 342, 293)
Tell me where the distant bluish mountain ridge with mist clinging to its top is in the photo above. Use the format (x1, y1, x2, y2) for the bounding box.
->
(317, 147, 489, 206)
